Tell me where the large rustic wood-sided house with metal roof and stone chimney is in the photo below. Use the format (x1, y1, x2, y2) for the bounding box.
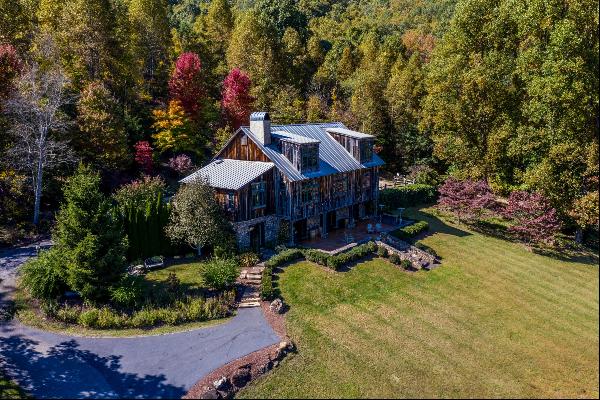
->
(182, 112, 384, 248)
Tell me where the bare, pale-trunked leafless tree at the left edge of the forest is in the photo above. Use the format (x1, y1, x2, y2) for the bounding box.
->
(5, 42, 73, 225)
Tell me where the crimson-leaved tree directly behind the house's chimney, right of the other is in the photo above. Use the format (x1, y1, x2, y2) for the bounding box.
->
(221, 68, 254, 129)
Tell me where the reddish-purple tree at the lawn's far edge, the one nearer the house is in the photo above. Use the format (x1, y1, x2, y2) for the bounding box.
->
(438, 178, 496, 222)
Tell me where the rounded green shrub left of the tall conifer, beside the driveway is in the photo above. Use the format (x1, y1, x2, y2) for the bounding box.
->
(21, 249, 67, 302)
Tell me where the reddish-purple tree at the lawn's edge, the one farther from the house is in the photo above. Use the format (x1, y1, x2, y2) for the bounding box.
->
(502, 190, 560, 243)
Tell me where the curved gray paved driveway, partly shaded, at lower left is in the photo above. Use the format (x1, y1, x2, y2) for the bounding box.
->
(0, 242, 279, 398)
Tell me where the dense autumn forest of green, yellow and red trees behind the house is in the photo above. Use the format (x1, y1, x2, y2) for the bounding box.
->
(0, 0, 600, 242)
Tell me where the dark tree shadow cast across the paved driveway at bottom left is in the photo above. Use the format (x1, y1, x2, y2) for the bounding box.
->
(0, 326, 186, 398)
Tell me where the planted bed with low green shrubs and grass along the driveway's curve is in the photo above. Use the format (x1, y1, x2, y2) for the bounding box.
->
(17, 263, 235, 336)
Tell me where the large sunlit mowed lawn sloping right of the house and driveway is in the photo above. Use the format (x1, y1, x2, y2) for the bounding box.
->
(240, 208, 599, 398)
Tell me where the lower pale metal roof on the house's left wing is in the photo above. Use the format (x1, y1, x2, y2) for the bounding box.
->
(180, 158, 274, 190)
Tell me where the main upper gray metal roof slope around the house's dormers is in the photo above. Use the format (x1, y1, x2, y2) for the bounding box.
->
(240, 122, 384, 181)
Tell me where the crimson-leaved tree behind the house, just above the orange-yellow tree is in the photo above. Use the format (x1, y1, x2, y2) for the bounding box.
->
(169, 52, 204, 120)
